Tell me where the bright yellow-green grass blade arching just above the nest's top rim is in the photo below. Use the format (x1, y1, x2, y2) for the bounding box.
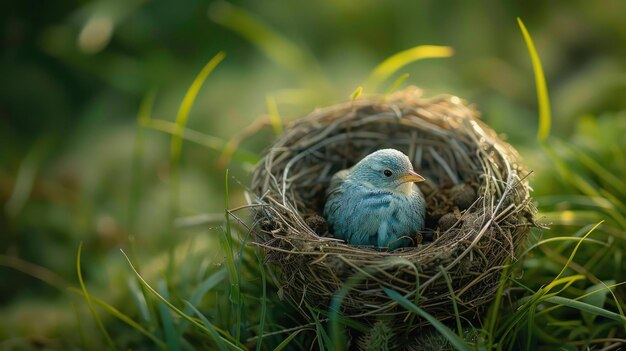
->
(363, 45, 454, 92)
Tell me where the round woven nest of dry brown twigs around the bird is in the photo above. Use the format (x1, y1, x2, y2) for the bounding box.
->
(252, 87, 536, 331)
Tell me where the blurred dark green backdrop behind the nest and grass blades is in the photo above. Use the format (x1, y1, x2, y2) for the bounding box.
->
(0, 0, 626, 349)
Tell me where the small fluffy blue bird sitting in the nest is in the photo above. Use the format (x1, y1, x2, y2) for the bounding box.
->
(324, 149, 426, 251)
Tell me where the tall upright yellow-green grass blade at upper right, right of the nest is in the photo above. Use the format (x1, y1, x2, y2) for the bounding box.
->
(517, 17, 552, 141)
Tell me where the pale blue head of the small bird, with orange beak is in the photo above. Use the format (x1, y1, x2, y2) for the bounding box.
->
(350, 149, 425, 193)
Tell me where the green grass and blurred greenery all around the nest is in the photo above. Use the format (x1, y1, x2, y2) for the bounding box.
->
(0, 1, 626, 351)
